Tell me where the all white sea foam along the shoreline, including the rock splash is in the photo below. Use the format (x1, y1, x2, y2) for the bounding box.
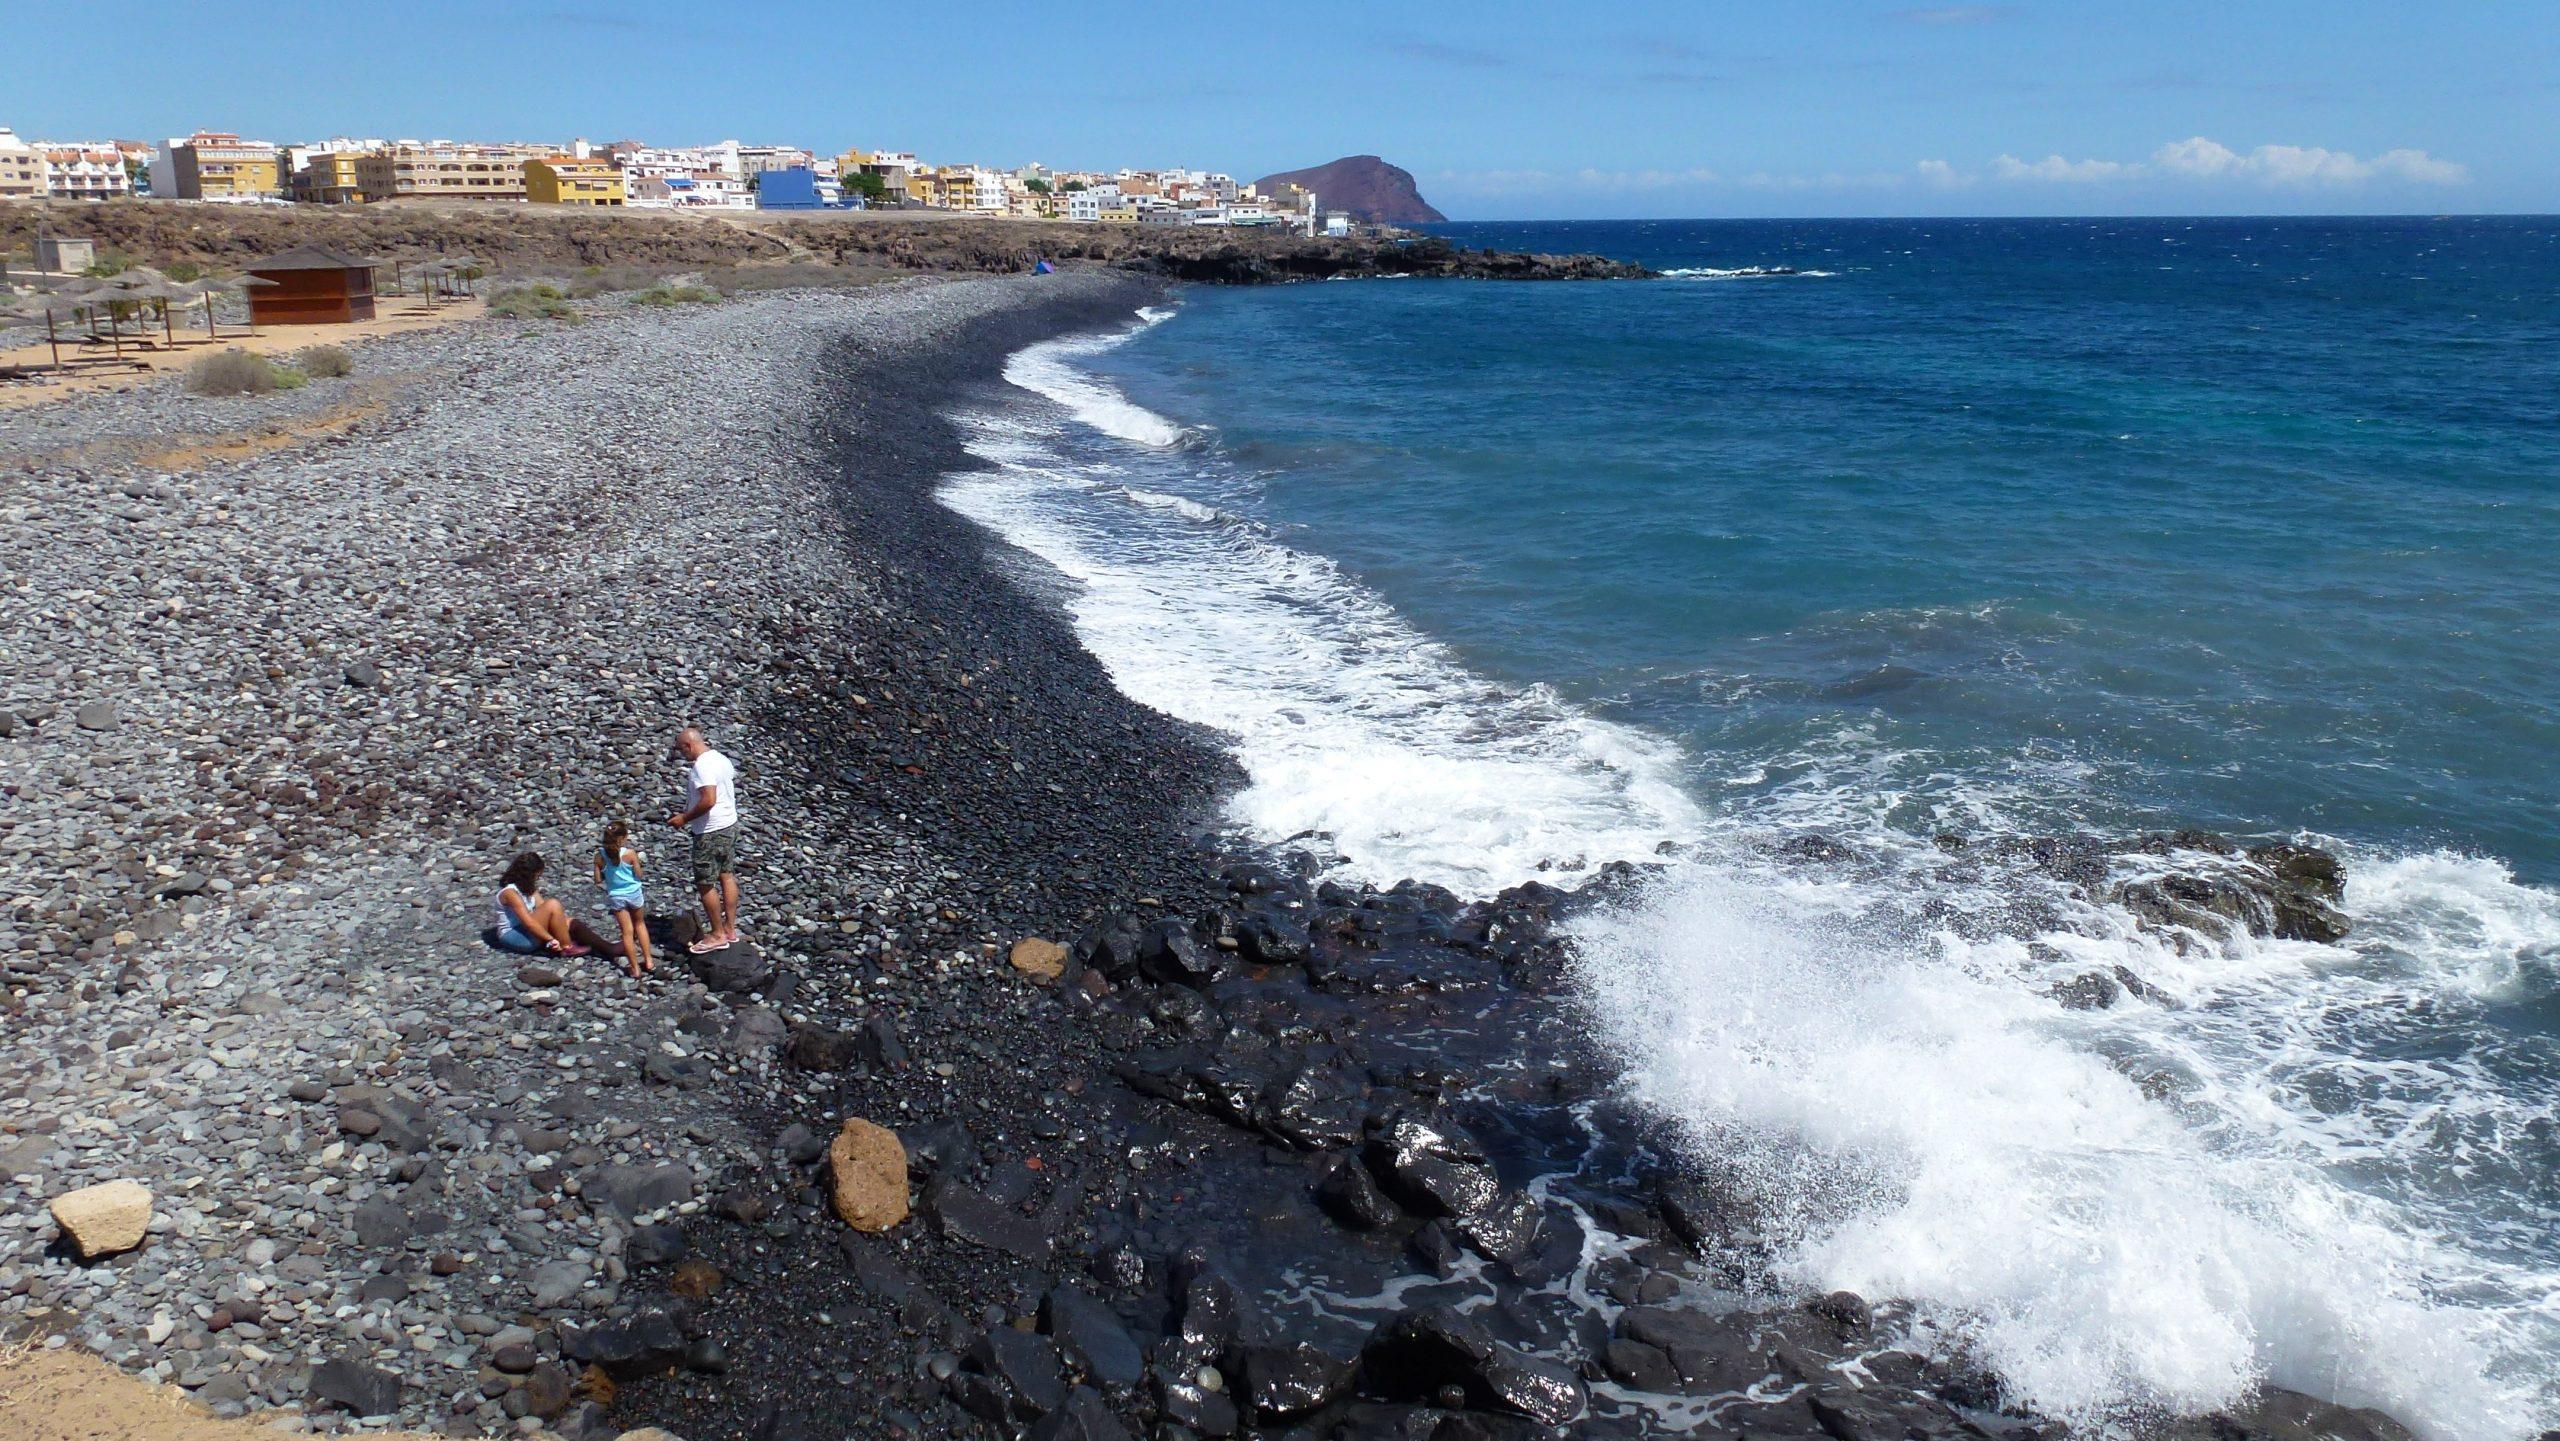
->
(945, 316, 2560, 1441)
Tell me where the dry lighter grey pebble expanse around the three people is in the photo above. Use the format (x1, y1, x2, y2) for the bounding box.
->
(0, 276, 1239, 1431)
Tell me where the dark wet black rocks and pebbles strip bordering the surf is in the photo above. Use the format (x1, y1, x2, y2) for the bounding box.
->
(586, 294, 2401, 1441)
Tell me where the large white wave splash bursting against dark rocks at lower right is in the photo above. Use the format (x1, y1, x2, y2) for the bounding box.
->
(1582, 863, 2550, 1438)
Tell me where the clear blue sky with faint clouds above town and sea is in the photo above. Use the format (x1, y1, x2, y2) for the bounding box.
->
(20, 0, 2560, 218)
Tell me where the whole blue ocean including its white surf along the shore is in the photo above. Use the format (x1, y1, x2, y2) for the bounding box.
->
(945, 218, 2560, 1441)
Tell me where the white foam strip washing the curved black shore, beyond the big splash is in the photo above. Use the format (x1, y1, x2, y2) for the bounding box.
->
(942, 323, 1700, 891)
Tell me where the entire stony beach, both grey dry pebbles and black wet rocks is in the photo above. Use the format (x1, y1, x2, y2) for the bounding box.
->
(0, 269, 2409, 1441)
